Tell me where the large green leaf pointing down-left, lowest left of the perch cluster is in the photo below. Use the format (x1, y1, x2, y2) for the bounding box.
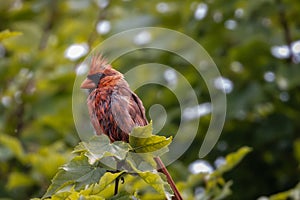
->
(44, 155, 106, 197)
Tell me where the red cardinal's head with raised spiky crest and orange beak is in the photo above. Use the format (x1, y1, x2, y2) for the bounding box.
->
(80, 55, 120, 91)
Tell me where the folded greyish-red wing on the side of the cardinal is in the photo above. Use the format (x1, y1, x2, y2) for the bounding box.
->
(111, 84, 147, 133)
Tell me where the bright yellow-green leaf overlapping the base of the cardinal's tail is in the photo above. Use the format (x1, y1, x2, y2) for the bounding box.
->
(129, 122, 172, 156)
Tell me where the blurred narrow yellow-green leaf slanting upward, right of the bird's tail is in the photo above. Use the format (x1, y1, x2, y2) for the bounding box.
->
(211, 147, 252, 177)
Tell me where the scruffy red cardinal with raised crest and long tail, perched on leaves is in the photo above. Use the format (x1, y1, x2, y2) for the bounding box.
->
(81, 55, 182, 200)
